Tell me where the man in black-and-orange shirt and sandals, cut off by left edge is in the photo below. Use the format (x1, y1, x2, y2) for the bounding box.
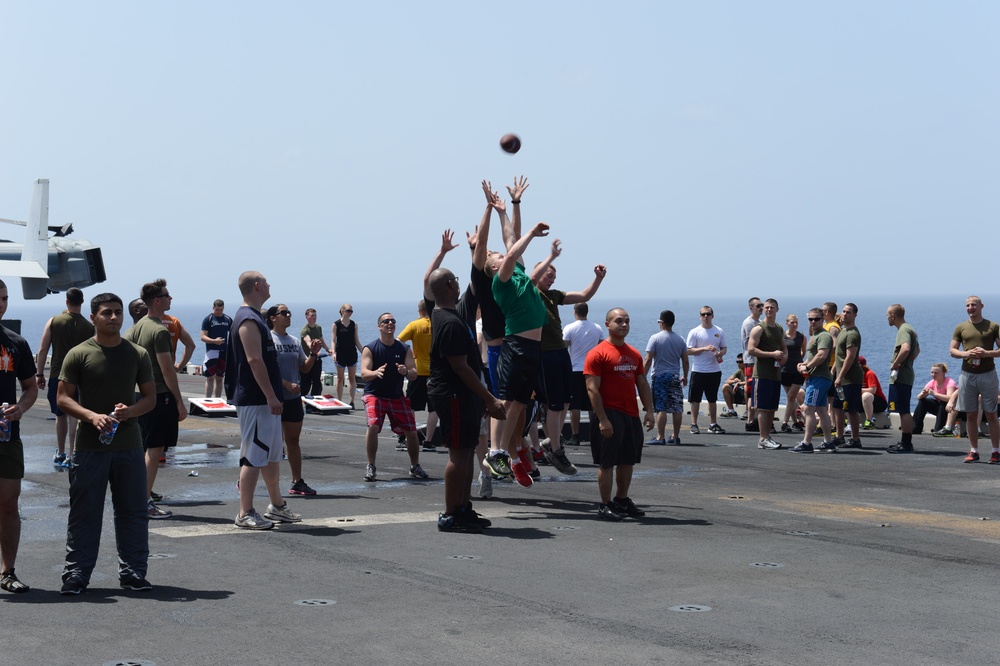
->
(0, 280, 38, 594)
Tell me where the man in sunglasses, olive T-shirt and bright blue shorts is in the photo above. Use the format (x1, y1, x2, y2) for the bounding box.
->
(791, 308, 837, 453)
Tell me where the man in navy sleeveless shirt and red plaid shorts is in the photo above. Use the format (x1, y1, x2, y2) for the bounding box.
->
(361, 312, 427, 481)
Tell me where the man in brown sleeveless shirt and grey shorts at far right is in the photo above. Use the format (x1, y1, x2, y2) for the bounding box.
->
(951, 296, 1000, 465)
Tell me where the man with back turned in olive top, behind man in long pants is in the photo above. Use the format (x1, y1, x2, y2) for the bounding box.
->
(35, 287, 94, 467)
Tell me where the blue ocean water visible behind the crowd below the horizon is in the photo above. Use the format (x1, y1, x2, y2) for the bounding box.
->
(6, 293, 1000, 404)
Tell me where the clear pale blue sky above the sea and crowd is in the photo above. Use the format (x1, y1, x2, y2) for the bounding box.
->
(0, 0, 1000, 304)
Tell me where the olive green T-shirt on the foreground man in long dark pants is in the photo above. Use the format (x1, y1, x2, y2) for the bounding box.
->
(59, 338, 154, 451)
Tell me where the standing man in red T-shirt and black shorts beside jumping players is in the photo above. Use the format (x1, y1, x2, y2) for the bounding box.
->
(583, 308, 654, 521)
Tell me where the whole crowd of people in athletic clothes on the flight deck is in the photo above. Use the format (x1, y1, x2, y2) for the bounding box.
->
(0, 177, 1000, 595)
